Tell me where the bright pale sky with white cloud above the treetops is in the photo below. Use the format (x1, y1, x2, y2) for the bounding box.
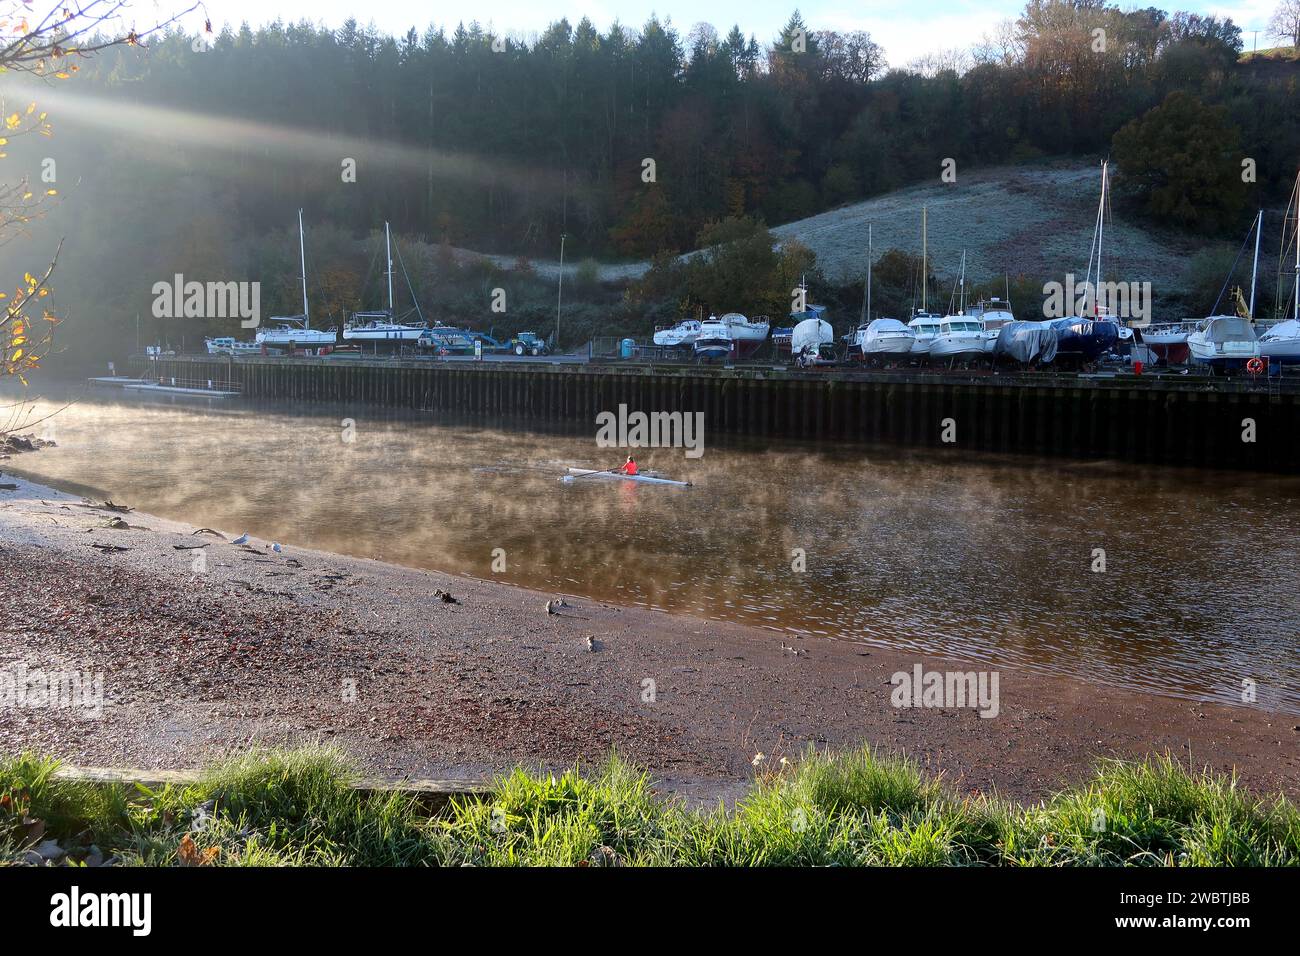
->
(172, 0, 1278, 66)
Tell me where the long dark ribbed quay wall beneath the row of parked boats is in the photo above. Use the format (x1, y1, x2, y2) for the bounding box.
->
(140, 356, 1300, 472)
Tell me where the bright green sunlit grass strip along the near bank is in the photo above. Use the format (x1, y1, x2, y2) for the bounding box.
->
(0, 748, 1300, 866)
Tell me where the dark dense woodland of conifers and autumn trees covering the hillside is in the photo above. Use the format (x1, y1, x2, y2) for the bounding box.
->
(10, 0, 1300, 358)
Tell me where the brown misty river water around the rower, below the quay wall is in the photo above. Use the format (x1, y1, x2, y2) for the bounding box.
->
(9, 397, 1300, 710)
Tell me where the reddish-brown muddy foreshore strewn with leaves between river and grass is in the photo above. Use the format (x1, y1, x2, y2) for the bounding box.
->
(0, 473, 1300, 800)
